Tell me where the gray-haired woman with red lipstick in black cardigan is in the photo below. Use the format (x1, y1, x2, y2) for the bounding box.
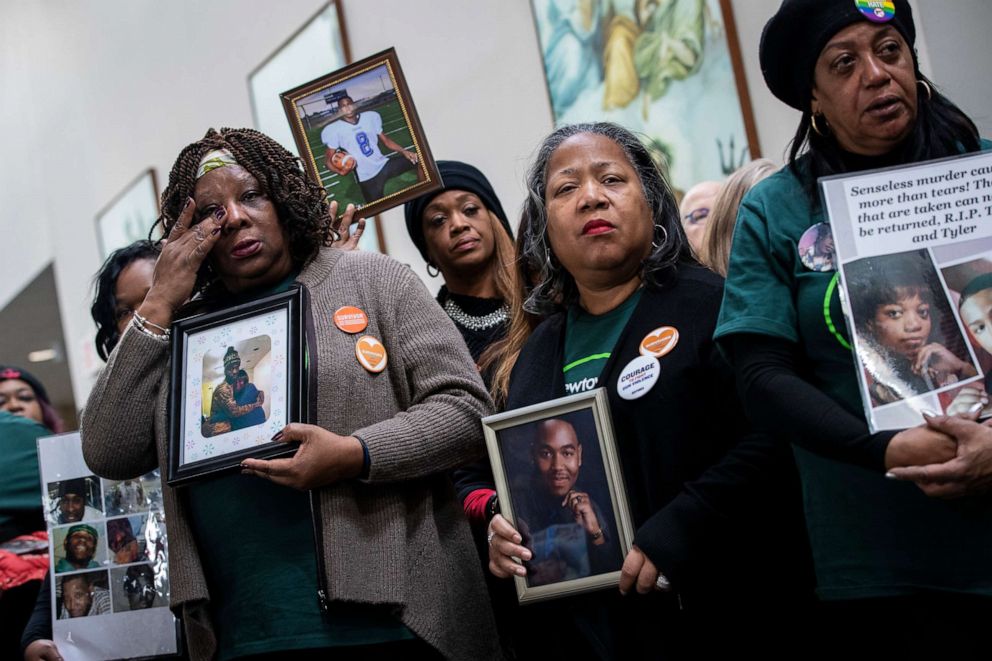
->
(489, 123, 810, 658)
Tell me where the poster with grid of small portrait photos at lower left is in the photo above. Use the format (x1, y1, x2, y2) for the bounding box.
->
(38, 432, 179, 661)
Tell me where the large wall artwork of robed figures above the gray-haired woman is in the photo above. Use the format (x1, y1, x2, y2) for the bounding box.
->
(532, 0, 760, 192)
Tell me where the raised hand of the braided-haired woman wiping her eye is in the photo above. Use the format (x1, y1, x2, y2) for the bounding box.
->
(138, 197, 227, 326)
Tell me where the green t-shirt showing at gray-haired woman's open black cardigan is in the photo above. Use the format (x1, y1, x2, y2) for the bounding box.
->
(562, 289, 641, 395)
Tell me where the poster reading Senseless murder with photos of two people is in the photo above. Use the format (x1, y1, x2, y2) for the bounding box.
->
(816, 153, 992, 432)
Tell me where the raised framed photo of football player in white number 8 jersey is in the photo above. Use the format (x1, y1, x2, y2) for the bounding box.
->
(280, 48, 441, 218)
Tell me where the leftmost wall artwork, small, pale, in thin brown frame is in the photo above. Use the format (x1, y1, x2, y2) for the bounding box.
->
(96, 168, 159, 261)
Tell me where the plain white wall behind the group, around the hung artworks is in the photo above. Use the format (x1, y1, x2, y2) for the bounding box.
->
(0, 0, 989, 404)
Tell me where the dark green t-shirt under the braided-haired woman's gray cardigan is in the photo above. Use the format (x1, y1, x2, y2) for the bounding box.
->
(182, 273, 414, 661)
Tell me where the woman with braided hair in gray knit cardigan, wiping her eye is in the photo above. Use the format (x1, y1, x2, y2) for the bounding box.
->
(82, 129, 499, 659)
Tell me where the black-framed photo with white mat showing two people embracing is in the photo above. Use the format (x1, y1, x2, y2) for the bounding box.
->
(167, 287, 308, 486)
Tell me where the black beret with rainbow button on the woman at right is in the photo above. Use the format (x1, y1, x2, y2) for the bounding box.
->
(758, 0, 916, 112)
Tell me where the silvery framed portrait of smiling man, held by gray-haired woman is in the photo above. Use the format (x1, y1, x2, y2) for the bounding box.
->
(482, 388, 634, 604)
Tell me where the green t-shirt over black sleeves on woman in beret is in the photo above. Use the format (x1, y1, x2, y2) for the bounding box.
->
(715, 152, 992, 599)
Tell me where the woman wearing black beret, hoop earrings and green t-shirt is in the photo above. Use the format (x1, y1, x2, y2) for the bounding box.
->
(716, 0, 992, 658)
